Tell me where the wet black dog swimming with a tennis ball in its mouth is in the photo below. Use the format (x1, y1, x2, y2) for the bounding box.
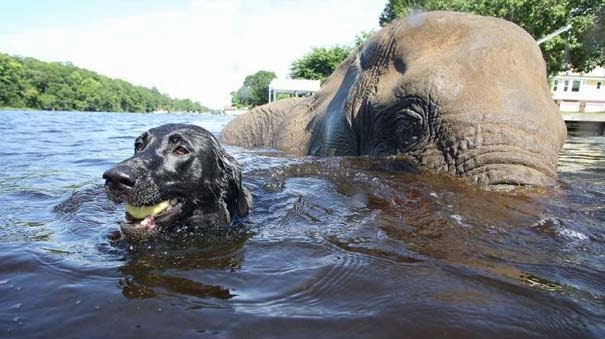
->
(103, 124, 251, 240)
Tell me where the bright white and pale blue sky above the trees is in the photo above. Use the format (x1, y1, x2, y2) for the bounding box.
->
(0, 0, 386, 108)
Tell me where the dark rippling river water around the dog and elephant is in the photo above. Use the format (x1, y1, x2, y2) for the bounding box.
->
(0, 112, 605, 338)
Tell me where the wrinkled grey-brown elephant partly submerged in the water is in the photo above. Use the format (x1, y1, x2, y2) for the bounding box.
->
(221, 12, 566, 185)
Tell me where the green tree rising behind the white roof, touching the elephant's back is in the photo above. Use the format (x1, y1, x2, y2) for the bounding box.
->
(290, 46, 352, 82)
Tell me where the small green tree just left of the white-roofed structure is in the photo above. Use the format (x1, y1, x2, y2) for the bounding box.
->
(231, 71, 277, 107)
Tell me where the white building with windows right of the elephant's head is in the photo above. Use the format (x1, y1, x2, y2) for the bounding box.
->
(551, 67, 605, 112)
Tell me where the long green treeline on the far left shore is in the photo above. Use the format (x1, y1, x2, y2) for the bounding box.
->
(0, 53, 210, 112)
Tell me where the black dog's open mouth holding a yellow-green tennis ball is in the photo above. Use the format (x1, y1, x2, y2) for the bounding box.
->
(120, 199, 183, 235)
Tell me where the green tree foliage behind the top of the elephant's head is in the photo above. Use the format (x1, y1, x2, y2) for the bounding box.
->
(379, 0, 605, 74)
